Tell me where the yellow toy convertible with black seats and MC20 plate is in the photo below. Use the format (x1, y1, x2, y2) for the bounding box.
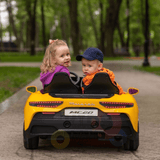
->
(23, 72, 139, 150)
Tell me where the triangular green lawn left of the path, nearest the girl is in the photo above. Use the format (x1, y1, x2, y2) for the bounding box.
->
(0, 67, 40, 102)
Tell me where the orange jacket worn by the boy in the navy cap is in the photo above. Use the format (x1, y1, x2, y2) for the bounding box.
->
(82, 68, 125, 94)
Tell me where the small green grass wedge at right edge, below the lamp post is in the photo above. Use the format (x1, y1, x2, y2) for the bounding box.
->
(134, 66, 160, 76)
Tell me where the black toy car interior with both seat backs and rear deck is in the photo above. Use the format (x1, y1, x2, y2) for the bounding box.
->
(43, 72, 119, 98)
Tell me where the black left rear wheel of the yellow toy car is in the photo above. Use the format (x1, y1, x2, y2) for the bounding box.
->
(23, 124, 39, 149)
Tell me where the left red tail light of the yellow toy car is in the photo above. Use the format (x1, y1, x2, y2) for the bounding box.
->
(29, 101, 63, 108)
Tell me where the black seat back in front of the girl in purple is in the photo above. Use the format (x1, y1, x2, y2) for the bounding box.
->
(44, 72, 80, 94)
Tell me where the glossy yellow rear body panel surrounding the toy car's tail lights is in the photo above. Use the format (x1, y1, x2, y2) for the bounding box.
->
(24, 91, 139, 132)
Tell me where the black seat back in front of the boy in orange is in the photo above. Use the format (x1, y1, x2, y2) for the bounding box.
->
(84, 73, 119, 94)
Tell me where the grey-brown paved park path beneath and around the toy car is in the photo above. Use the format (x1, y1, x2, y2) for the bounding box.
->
(0, 61, 160, 160)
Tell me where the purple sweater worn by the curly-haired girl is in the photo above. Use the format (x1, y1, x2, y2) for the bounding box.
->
(40, 66, 70, 88)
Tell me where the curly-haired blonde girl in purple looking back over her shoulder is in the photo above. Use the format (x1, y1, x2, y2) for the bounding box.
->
(40, 40, 71, 88)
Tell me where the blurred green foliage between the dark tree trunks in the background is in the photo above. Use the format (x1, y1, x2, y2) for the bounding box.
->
(0, 0, 160, 57)
